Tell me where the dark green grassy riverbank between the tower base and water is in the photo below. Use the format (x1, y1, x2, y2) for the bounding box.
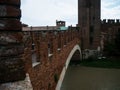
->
(70, 58, 120, 69)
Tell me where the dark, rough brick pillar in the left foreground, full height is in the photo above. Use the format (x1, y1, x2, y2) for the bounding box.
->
(0, 0, 25, 83)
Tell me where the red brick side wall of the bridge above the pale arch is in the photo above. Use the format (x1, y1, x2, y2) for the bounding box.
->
(23, 28, 80, 90)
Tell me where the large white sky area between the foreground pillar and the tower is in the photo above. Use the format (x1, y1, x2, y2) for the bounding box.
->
(21, 0, 77, 25)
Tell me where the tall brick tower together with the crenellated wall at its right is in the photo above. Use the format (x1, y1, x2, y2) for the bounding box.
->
(78, 0, 120, 49)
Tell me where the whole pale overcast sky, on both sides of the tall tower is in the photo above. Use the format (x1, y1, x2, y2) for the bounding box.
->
(21, 0, 120, 26)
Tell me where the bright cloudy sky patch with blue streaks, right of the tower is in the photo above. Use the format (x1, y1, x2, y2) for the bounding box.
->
(101, 0, 120, 19)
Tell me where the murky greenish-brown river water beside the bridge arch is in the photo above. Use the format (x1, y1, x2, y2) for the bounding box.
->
(61, 65, 120, 90)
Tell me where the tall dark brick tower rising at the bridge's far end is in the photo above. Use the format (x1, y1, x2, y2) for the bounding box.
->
(78, 0, 101, 49)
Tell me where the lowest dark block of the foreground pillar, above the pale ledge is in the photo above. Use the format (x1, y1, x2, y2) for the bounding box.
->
(0, 56, 25, 83)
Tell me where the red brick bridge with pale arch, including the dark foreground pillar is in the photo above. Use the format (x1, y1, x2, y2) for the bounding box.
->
(0, 0, 81, 90)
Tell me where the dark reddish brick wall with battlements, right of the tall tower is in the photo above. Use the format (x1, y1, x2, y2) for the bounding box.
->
(101, 19, 120, 41)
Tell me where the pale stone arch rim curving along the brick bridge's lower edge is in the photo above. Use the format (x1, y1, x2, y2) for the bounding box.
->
(55, 44, 82, 90)
